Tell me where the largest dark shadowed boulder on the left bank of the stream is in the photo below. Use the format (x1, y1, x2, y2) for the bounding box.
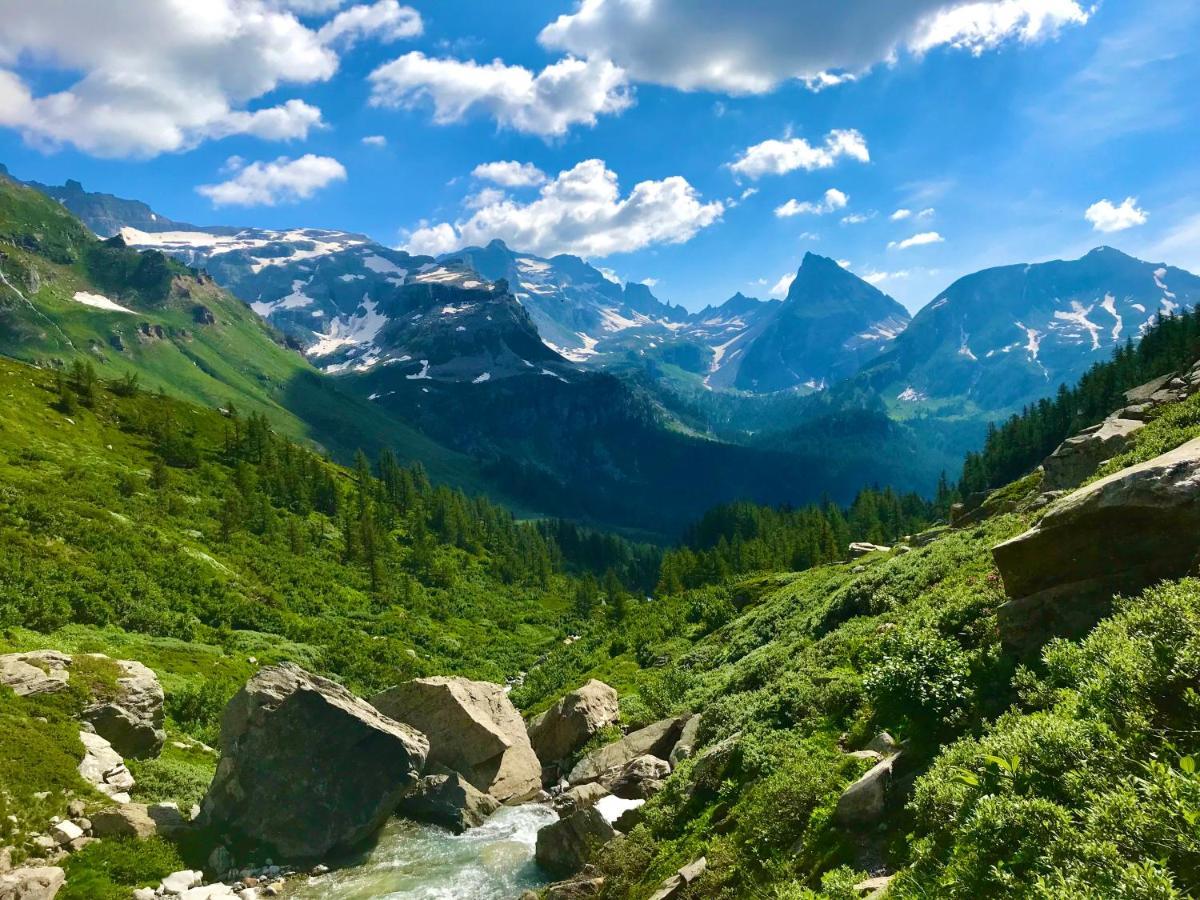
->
(202, 664, 428, 859)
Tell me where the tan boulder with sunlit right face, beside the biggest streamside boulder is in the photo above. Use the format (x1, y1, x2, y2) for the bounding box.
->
(371, 677, 541, 803)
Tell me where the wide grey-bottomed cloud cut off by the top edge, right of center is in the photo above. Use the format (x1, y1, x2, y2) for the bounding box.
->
(539, 0, 1088, 94)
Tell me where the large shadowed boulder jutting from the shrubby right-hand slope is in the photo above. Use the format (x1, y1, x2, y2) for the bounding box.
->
(992, 439, 1200, 654)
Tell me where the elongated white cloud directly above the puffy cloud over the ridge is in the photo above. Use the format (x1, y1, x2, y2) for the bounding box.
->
(371, 52, 632, 137)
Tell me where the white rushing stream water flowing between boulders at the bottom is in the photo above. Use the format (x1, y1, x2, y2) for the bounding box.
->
(293, 804, 558, 900)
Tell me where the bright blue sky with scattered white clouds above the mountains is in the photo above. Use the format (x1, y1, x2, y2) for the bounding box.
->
(0, 0, 1200, 310)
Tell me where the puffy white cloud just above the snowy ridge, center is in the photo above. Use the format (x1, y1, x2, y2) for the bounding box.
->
(407, 160, 725, 258)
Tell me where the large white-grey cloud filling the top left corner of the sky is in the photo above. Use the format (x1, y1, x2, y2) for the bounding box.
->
(0, 0, 338, 157)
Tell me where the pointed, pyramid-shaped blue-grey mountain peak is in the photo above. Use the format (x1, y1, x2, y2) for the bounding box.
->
(734, 253, 908, 392)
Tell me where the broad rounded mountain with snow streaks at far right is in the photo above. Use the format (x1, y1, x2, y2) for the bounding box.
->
(864, 247, 1200, 414)
